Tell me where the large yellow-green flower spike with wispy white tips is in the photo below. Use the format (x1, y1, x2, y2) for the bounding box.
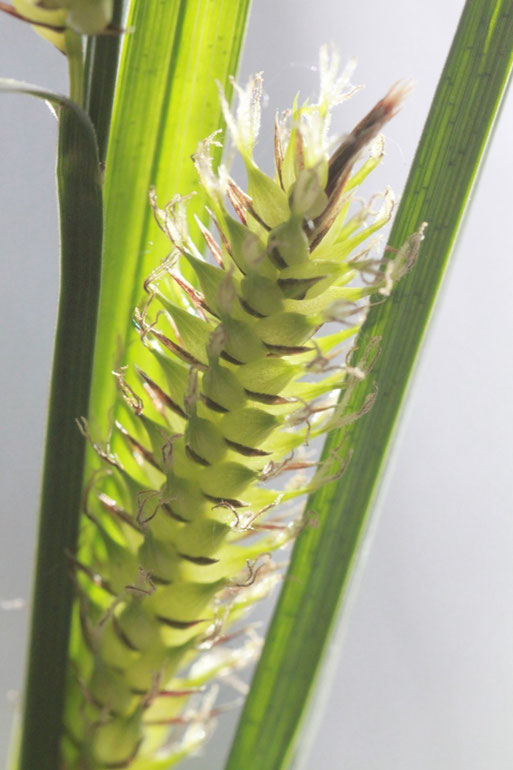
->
(62, 50, 421, 770)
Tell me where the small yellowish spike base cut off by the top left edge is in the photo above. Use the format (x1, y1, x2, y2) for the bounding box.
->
(12, 0, 113, 52)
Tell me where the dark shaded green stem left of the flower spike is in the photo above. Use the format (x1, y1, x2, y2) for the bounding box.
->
(19, 106, 102, 770)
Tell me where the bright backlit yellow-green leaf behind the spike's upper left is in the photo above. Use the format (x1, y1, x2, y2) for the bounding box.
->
(85, 0, 249, 450)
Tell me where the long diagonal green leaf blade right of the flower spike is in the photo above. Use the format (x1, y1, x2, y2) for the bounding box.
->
(226, 0, 513, 770)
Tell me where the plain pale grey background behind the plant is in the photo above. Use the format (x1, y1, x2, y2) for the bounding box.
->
(0, 0, 513, 770)
